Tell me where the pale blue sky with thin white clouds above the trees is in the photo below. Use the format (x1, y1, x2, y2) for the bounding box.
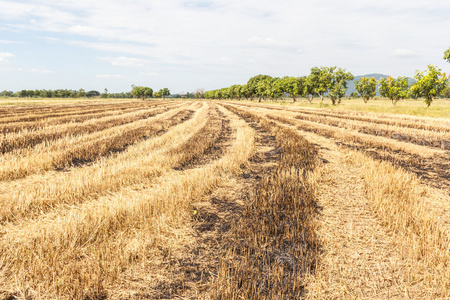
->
(0, 0, 450, 94)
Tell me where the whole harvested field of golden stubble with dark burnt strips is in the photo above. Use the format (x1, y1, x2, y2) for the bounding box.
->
(0, 100, 450, 300)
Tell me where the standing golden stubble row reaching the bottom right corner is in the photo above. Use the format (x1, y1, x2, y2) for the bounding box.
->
(358, 153, 450, 298)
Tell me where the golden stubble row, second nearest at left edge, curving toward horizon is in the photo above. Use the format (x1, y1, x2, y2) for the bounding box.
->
(0, 102, 206, 223)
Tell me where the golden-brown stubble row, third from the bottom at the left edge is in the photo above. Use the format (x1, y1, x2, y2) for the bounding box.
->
(0, 104, 195, 180)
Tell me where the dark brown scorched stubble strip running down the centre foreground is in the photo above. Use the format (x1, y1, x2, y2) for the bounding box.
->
(212, 107, 319, 299)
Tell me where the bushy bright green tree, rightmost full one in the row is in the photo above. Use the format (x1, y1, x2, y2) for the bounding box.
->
(410, 65, 448, 107)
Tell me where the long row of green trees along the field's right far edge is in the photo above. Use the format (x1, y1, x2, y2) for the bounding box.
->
(205, 64, 450, 106)
